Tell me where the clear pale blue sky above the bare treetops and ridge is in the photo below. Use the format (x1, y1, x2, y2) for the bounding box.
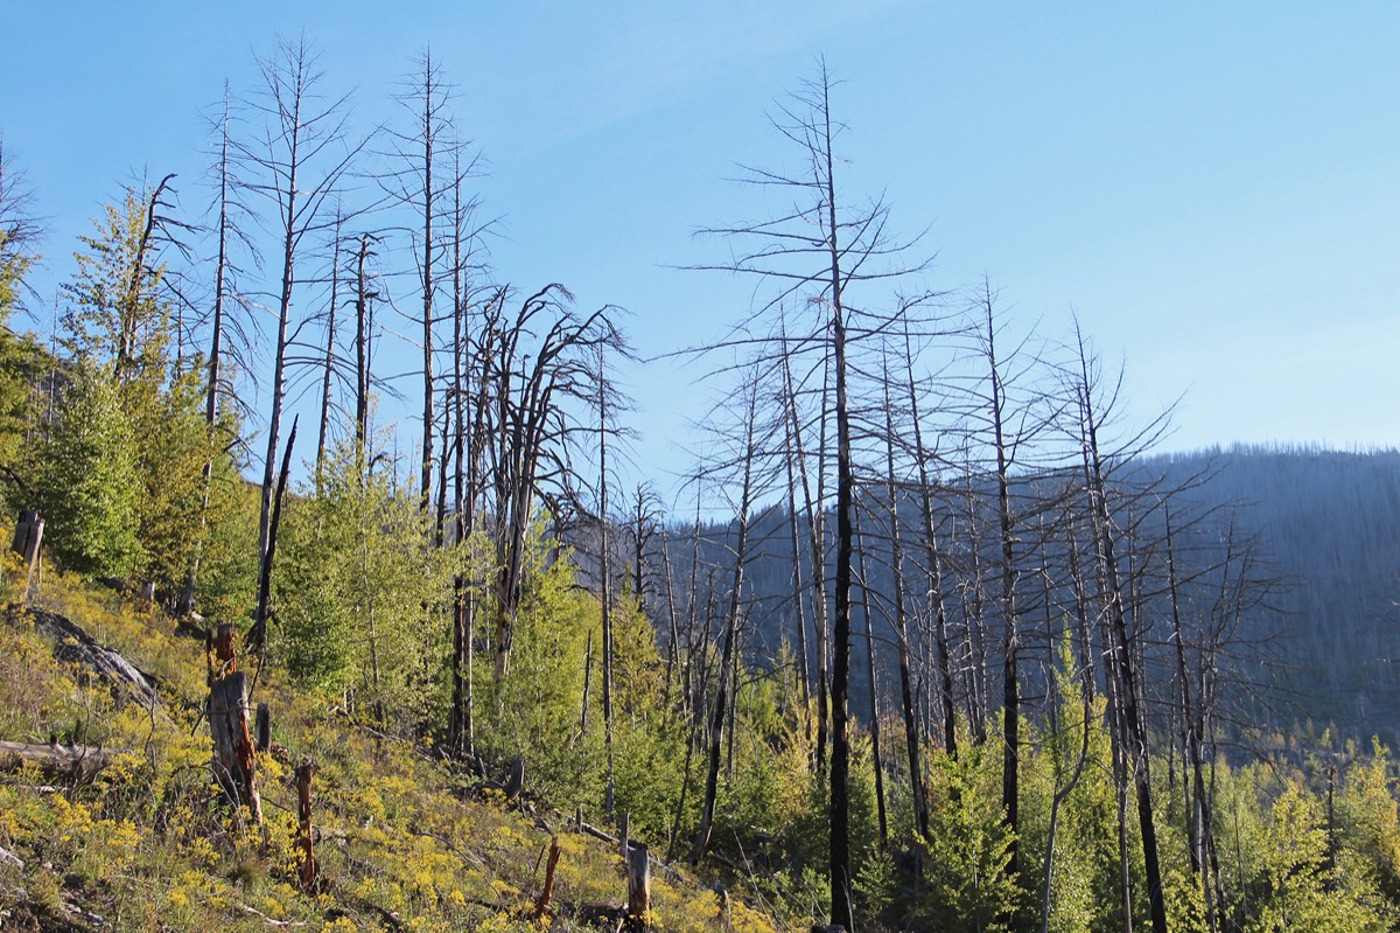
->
(0, 0, 1400, 504)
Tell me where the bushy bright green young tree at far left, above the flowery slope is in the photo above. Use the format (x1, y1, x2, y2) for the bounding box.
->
(34, 370, 143, 577)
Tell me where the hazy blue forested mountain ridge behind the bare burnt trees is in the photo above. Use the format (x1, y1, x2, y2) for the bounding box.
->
(646, 445, 1400, 747)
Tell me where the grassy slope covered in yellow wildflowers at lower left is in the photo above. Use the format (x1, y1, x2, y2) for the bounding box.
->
(0, 554, 776, 932)
